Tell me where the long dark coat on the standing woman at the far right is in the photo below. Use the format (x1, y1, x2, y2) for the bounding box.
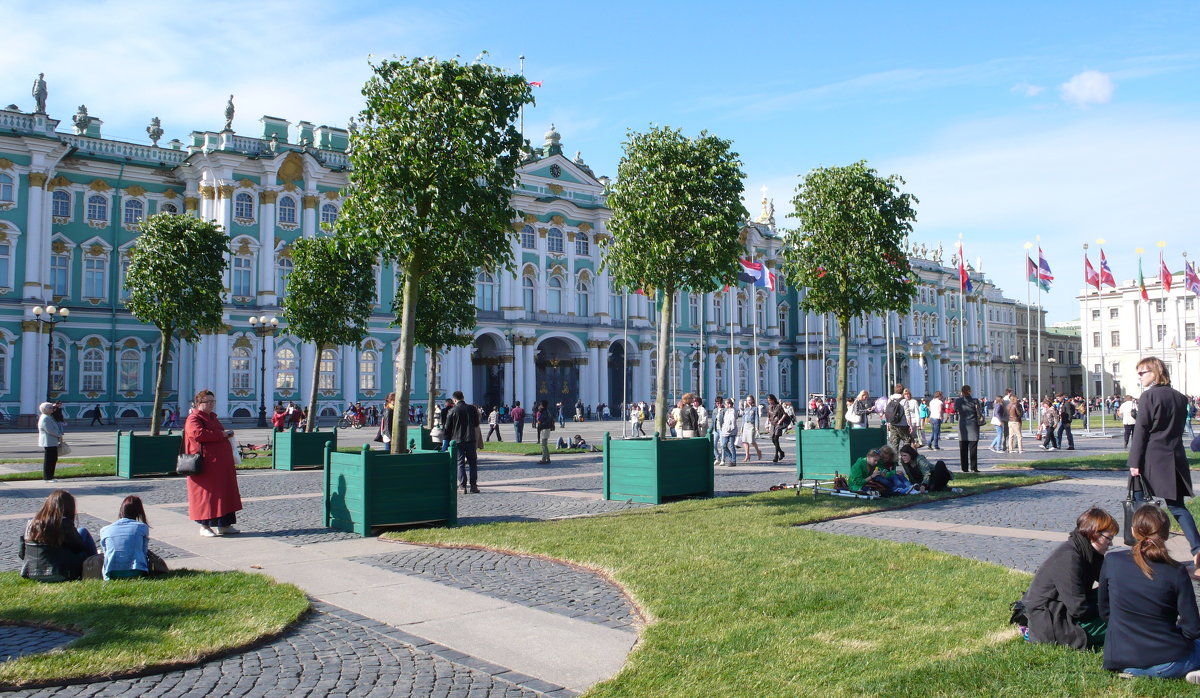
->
(1129, 385, 1193, 500)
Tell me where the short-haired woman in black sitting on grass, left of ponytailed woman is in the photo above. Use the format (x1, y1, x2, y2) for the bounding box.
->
(1021, 506, 1118, 650)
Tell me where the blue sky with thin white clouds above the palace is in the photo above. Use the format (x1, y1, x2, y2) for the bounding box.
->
(0, 0, 1200, 321)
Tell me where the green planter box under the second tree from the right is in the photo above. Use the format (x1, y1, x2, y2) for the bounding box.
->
(604, 432, 713, 504)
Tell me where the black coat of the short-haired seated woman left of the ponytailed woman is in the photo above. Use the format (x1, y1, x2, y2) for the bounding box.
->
(1022, 530, 1104, 650)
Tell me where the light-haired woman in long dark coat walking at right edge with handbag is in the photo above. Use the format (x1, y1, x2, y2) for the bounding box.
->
(1128, 356, 1200, 578)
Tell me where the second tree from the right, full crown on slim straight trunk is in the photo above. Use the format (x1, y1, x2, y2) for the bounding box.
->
(604, 127, 749, 434)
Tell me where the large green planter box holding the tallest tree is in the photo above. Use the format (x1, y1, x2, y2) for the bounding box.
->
(325, 444, 458, 536)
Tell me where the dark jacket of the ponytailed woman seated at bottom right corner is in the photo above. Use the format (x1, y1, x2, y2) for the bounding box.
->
(1099, 551, 1200, 672)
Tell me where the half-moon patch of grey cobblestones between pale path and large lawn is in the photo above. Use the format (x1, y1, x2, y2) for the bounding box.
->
(354, 548, 637, 631)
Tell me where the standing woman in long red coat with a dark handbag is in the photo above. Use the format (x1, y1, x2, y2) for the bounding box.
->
(184, 390, 241, 537)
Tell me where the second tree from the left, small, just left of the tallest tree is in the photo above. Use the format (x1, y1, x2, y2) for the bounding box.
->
(283, 236, 376, 432)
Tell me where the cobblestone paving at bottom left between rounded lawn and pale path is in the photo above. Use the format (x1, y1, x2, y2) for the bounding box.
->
(2, 603, 576, 698)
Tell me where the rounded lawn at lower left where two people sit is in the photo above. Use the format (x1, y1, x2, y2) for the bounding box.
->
(0, 570, 308, 688)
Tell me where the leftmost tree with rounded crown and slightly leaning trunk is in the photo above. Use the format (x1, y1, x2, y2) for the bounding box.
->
(125, 213, 229, 437)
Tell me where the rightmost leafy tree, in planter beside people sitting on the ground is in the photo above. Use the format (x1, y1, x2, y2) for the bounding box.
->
(784, 161, 918, 429)
